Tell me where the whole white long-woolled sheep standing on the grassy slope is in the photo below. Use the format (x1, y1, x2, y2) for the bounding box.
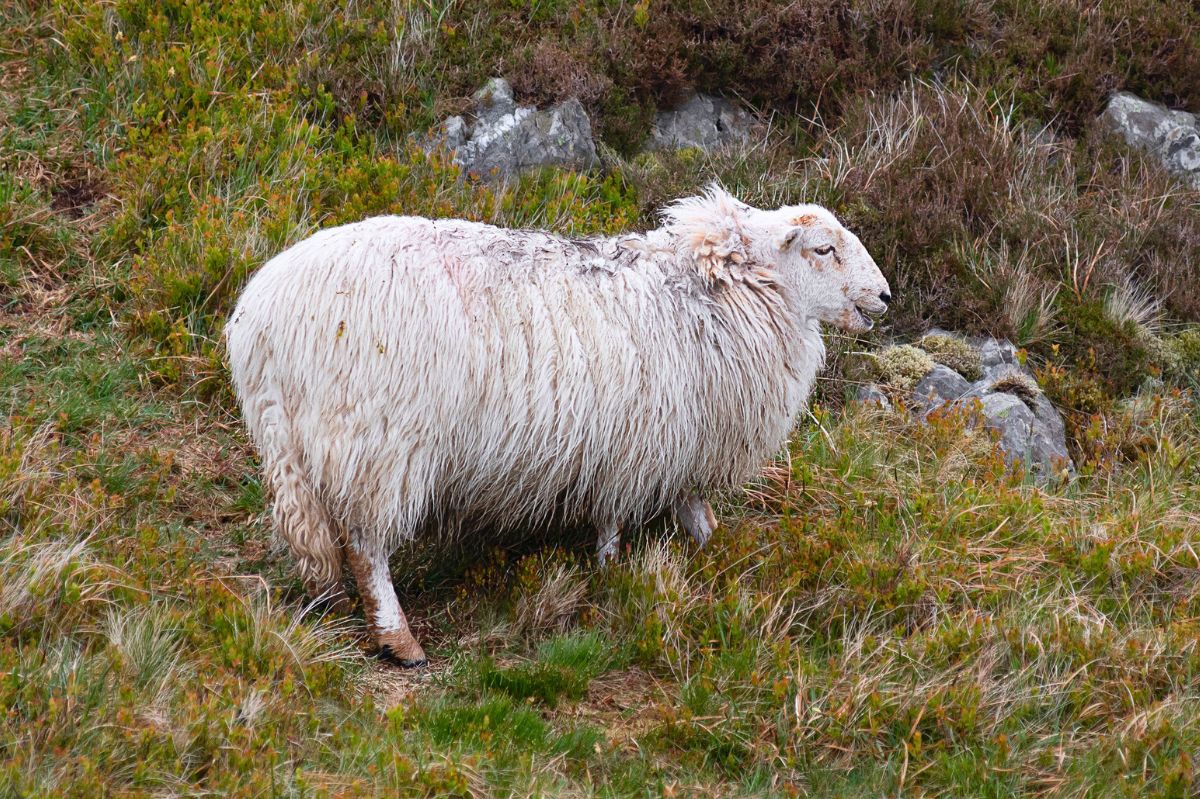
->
(226, 185, 890, 667)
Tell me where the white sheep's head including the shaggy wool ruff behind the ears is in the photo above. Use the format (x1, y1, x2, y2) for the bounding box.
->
(666, 185, 892, 331)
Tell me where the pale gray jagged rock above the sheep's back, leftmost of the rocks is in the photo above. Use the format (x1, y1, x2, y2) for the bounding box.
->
(426, 78, 599, 178)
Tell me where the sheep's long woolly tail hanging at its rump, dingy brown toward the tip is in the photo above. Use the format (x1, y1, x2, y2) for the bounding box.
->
(256, 391, 344, 601)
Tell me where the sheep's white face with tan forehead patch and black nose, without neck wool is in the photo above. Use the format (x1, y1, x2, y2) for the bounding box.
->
(770, 205, 892, 332)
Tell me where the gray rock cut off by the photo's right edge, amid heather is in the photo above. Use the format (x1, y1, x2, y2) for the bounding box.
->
(1100, 91, 1200, 188)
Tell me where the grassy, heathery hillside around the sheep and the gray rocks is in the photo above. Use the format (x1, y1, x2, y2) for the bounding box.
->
(0, 0, 1200, 797)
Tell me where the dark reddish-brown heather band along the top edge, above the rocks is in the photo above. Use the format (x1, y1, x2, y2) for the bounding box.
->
(537, 0, 1200, 138)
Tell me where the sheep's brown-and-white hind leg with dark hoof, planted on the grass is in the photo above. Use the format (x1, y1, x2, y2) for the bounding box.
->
(346, 534, 428, 668)
